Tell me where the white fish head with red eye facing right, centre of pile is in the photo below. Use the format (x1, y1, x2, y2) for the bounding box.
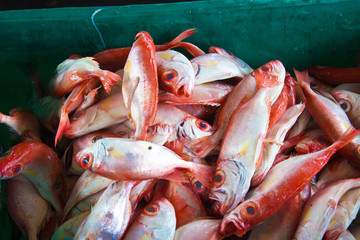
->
(178, 116, 213, 140)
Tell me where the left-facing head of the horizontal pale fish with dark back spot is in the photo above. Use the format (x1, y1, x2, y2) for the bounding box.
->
(74, 138, 109, 171)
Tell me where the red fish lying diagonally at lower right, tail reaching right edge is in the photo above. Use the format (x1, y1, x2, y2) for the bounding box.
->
(220, 128, 360, 236)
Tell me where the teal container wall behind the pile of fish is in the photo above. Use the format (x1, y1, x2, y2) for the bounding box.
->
(0, 0, 360, 239)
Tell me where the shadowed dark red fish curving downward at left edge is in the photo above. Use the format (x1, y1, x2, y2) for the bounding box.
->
(0, 141, 66, 218)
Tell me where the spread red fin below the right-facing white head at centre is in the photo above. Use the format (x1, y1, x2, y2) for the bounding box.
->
(185, 132, 220, 158)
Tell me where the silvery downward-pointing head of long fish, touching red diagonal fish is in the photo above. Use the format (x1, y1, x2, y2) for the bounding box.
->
(209, 159, 250, 216)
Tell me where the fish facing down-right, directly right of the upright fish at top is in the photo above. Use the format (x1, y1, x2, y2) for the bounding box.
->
(156, 50, 195, 97)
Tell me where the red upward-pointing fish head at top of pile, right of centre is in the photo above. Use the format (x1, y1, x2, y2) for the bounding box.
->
(251, 60, 286, 88)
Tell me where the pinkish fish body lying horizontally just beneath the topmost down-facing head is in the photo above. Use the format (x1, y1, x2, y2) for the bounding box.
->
(159, 82, 233, 107)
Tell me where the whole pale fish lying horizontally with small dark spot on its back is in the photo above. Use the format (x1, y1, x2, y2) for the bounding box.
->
(75, 138, 213, 187)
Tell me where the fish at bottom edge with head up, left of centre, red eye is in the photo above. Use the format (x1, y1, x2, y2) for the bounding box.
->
(123, 198, 176, 240)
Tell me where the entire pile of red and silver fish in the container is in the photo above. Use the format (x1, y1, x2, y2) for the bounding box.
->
(0, 29, 360, 240)
